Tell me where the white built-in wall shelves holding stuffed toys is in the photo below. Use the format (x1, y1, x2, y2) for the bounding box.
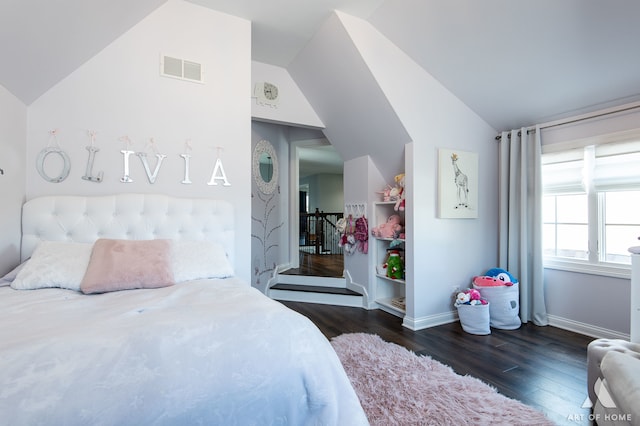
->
(372, 201, 406, 318)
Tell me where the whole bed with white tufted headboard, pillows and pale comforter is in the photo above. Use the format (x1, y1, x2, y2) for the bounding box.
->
(0, 194, 367, 425)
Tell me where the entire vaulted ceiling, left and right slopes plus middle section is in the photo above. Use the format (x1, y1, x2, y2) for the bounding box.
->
(0, 0, 640, 130)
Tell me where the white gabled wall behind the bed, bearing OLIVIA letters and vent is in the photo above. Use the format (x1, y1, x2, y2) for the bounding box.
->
(26, 0, 251, 281)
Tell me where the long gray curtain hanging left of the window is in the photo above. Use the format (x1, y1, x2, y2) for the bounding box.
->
(499, 128, 549, 325)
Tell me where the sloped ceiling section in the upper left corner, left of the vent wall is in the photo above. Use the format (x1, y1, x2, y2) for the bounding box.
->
(0, 0, 167, 105)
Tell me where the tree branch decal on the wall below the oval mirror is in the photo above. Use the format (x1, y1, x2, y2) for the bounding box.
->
(251, 191, 284, 291)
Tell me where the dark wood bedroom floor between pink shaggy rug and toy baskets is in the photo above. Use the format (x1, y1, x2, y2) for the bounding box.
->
(283, 302, 593, 425)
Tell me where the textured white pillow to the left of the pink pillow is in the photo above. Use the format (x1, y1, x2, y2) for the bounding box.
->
(11, 241, 93, 291)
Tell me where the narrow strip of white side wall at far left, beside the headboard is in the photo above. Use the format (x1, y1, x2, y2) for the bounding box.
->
(0, 86, 27, 276)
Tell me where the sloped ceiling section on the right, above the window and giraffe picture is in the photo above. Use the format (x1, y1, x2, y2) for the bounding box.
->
(367, 0, 640, 130)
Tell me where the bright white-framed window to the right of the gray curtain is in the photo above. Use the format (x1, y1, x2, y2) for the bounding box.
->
(542, 141, 640, 273)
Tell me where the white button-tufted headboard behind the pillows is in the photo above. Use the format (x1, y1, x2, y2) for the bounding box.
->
(20, 194, 235, 265)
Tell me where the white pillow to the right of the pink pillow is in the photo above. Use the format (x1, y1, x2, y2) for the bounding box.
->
(170, 241, 233, 283)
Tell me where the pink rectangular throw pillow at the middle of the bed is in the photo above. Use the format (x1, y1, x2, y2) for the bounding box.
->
(80, 239, 175, 294)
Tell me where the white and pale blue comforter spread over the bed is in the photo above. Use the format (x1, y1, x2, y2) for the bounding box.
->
(0, 279, 367, 426)
